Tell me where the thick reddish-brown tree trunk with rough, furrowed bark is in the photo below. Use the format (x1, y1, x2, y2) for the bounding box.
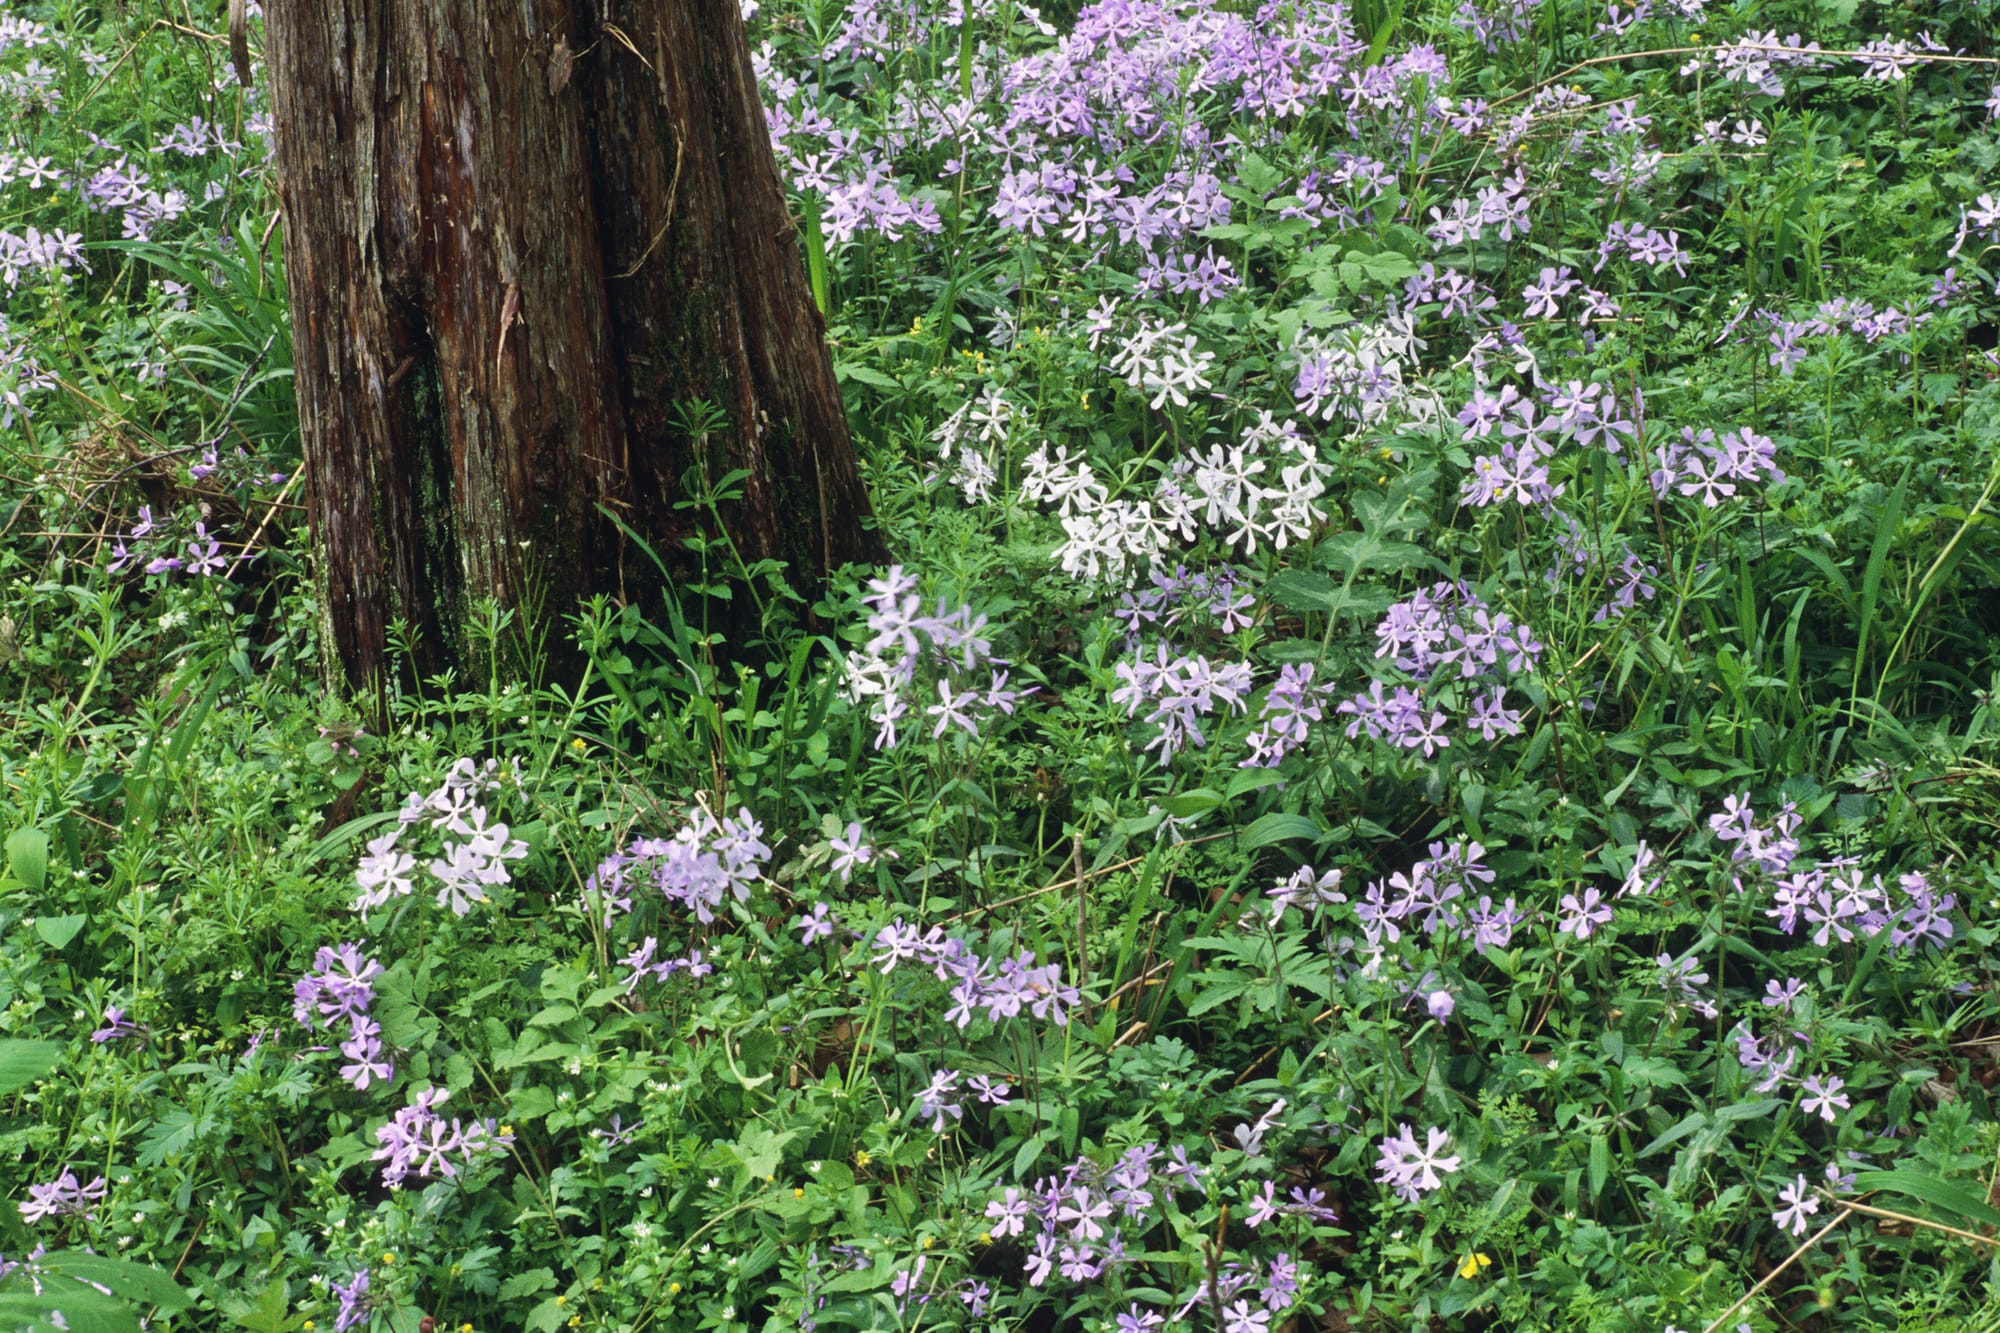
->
(266, 0, 880, 687)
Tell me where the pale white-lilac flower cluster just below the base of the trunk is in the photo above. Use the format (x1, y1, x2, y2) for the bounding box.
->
(354, 759, 528, 917)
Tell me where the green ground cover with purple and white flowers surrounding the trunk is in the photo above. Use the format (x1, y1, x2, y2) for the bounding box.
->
(0, 0, 2000, 1333)
